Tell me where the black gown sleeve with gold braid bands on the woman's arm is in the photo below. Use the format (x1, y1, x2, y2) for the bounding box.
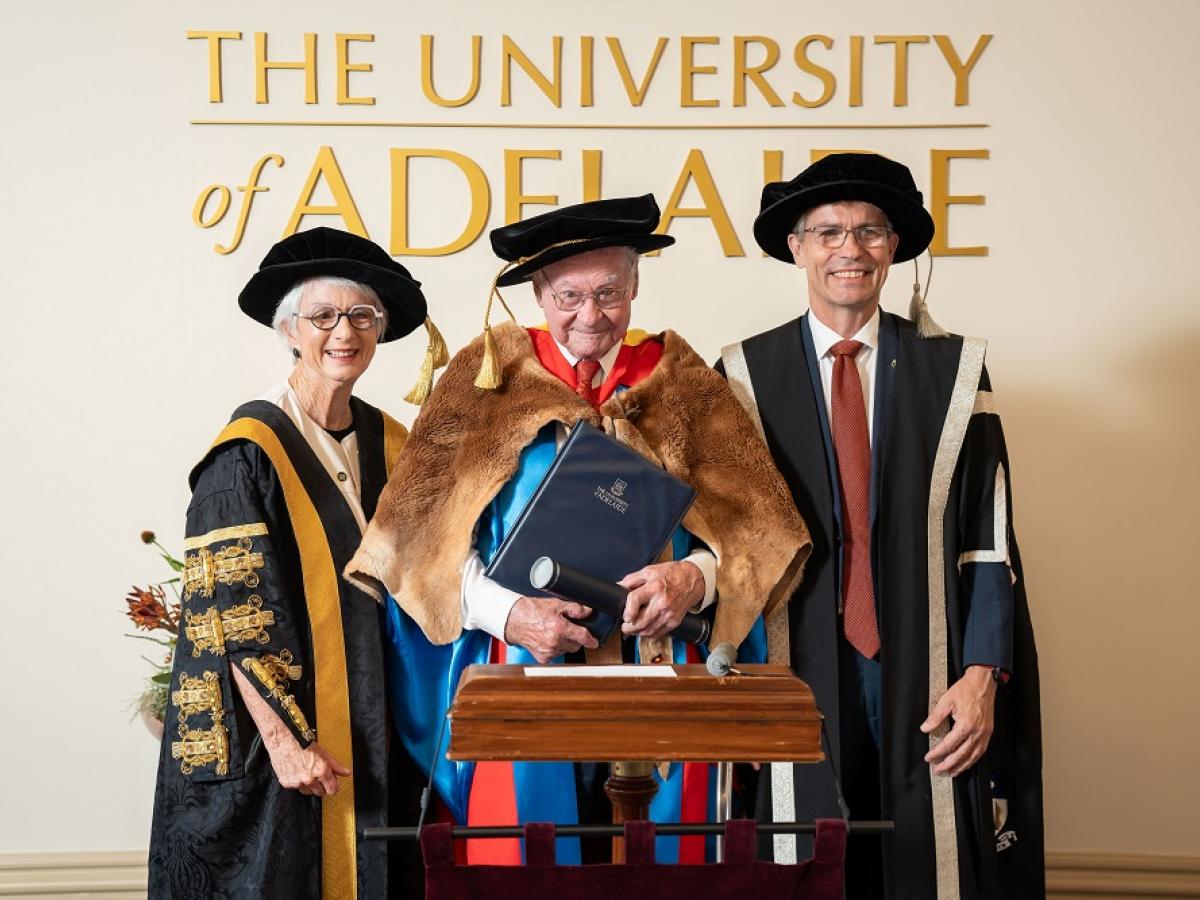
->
(166, 443, 316, 781)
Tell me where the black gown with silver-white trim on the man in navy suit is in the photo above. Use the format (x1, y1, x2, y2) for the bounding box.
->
(719, 313, 1045, 900)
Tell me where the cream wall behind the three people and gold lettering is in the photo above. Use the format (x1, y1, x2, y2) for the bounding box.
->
(0, 0, 1200, 854)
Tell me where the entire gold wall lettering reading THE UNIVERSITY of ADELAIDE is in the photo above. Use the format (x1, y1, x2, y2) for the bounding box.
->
(186, 29, 994, 257)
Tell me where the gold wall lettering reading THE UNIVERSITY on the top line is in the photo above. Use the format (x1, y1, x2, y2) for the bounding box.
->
(186, 29, 992, 109)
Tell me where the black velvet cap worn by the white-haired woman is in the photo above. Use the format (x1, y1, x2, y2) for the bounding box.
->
(238, 228, 426, 343)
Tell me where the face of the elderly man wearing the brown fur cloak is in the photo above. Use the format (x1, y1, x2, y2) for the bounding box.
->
(533, 247, 637, 359)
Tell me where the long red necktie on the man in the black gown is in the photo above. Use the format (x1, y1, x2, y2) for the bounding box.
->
(829, 341, 880, 659)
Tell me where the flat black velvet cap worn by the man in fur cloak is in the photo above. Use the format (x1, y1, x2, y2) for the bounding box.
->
(490, 193, 674, 287)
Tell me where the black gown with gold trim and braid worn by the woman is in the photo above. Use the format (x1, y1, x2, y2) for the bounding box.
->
(149, 398, 403, 900)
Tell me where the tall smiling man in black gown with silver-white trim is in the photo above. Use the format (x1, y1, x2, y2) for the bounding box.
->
(720, 154, 1045, 900)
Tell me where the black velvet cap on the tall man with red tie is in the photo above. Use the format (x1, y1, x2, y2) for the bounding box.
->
(754, 154, 934, 263)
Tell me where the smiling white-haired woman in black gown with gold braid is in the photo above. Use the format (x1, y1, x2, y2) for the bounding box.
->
(149, 228, 442, 900)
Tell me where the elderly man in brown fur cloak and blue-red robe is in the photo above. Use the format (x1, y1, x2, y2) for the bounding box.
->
(347, 194, 810, 863)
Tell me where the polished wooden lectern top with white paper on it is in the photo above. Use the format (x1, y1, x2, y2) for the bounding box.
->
(448, 665, 824, 762)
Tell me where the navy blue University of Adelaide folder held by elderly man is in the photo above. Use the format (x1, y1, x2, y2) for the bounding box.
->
(484, 421, 696, 643)
